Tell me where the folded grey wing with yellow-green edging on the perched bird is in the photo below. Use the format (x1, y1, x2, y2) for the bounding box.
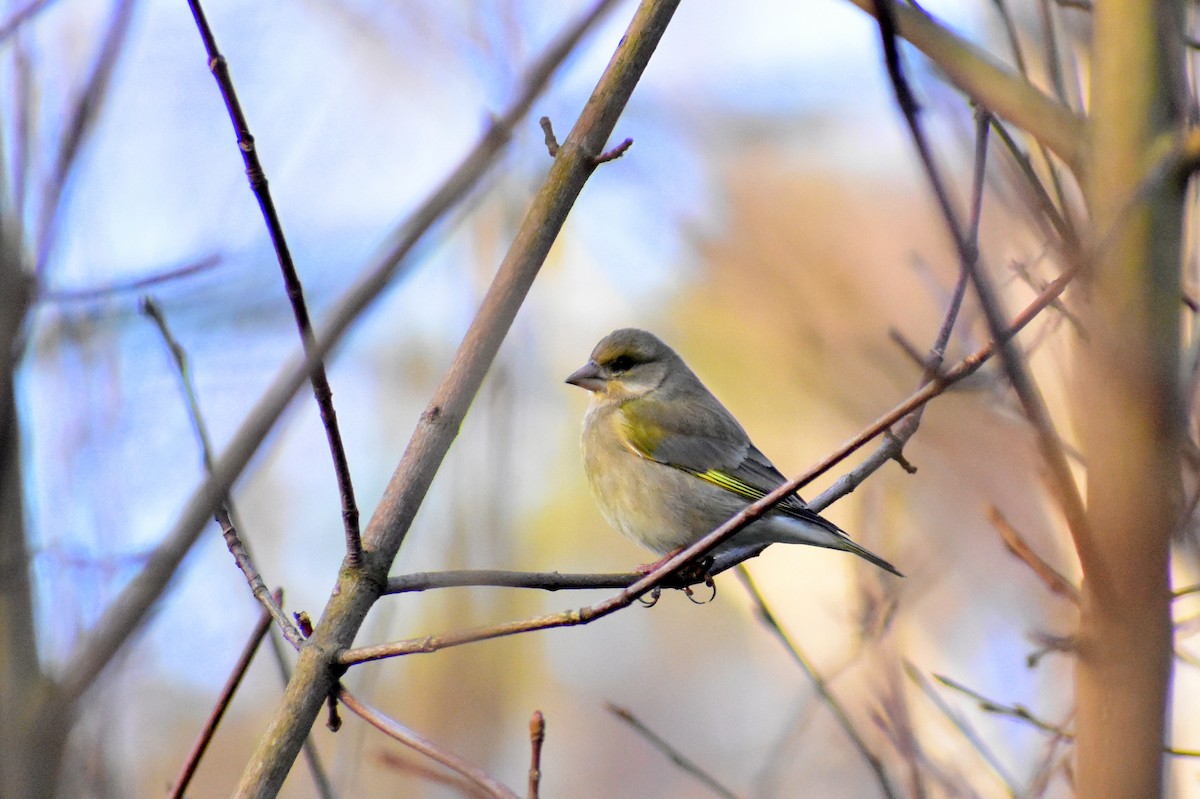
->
(622, 398, 816, 515)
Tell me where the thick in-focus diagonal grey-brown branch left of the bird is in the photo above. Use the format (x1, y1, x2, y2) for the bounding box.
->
(236, 0, 678, 797)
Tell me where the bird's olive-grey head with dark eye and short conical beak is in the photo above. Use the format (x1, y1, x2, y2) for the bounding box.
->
(566, 328, 686, 402)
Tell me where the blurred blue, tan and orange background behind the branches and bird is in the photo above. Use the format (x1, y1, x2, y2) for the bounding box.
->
(9, 0, 1200, 799)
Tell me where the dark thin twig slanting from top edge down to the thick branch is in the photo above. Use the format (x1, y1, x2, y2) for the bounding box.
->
(187, 0, 362, 569)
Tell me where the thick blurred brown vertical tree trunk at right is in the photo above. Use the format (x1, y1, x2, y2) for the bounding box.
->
(1075, 0, 1184, 799)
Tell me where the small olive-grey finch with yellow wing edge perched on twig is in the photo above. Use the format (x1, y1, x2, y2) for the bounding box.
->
(566, 328, 902, 576)
